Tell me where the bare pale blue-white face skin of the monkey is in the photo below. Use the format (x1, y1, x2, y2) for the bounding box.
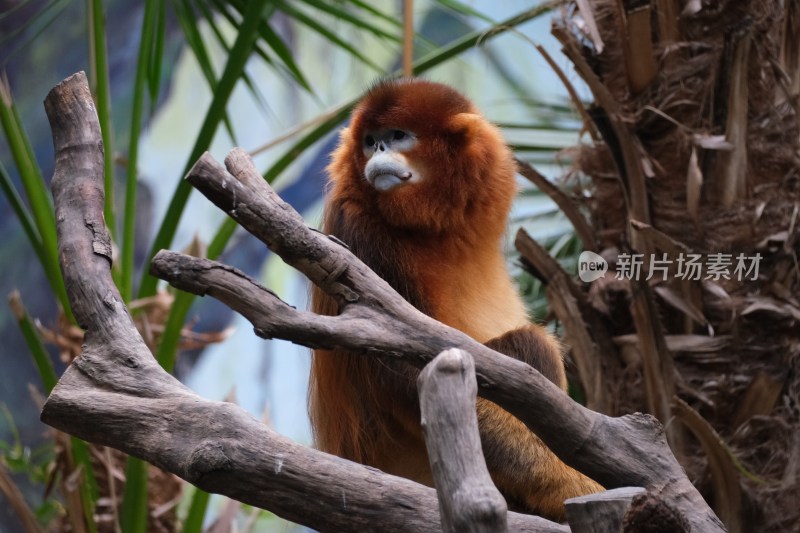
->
(363, 129, 422, 192)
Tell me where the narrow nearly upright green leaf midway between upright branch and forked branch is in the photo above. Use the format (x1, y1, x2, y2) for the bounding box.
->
(119, 0, 158, 302)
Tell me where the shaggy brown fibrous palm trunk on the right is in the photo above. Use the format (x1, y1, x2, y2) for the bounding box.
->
(523, 0, 800, 532)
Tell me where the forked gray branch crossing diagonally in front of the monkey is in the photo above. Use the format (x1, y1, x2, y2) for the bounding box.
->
(152, 149, 723, 531)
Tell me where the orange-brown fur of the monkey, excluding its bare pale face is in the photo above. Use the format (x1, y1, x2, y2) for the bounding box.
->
(309, 80, 599, 517)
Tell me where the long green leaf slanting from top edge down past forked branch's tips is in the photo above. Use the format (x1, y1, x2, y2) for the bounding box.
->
(139, 0, 274, 297)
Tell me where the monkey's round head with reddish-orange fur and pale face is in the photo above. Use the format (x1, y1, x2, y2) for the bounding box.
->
(328, 79, 516, 238)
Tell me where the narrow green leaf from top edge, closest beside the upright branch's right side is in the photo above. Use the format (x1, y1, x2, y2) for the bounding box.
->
(86, 0, 117, 239)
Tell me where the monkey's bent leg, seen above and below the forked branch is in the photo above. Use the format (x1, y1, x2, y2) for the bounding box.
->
(478, 325, 603, 520)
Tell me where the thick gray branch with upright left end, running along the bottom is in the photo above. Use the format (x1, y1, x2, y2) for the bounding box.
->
(37, 73, 563, 532)
